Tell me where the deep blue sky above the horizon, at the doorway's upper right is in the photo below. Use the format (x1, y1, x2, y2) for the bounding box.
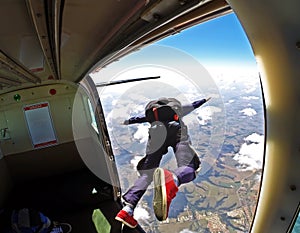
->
(156, 13, 256, 67)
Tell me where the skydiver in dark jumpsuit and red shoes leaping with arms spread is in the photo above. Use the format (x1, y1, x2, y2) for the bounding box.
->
(115, 98, 211, 228)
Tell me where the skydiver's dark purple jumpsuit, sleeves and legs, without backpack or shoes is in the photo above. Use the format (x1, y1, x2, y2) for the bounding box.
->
(123, 99, 206, 208)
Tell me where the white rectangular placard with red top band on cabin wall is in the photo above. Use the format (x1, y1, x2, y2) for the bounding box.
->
(23, 102, 57, 148)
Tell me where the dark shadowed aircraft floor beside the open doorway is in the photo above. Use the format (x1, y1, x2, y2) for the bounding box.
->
(5, 169, 144, 233)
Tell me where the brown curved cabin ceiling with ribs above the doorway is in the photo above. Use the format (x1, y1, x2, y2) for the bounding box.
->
(0, 0, 231, 92)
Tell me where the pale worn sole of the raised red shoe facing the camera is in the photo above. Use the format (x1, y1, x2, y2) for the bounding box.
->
(153, 168, 167, 221)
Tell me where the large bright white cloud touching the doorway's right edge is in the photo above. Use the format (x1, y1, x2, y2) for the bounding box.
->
(233, 133, 264, 171)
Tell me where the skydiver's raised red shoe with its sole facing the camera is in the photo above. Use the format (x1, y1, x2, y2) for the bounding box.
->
(153, 168, 178, 221)
